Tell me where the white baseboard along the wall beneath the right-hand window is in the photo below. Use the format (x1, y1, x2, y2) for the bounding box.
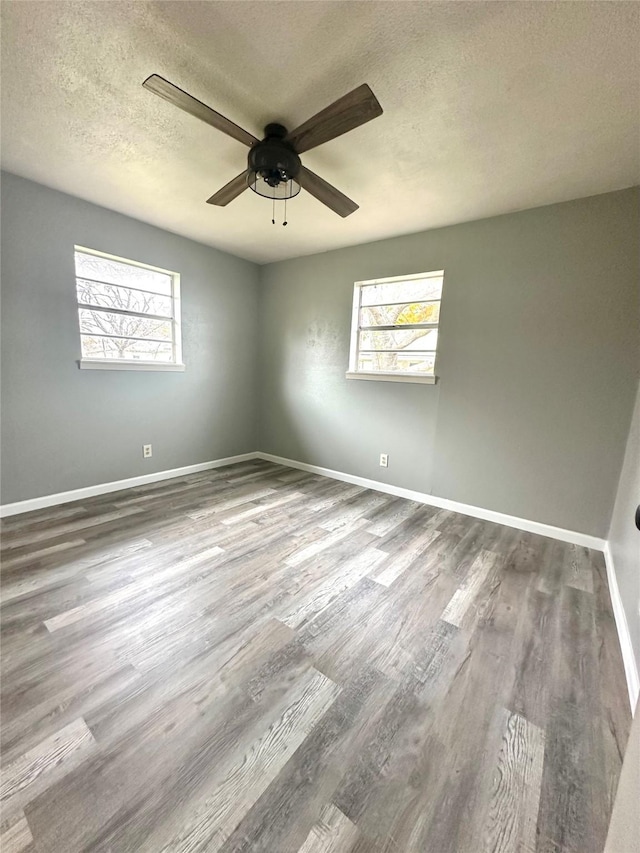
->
(256, 452, 605, 551)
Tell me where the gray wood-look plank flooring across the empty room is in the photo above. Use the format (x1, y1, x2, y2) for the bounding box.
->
(0, 461, 630, 853)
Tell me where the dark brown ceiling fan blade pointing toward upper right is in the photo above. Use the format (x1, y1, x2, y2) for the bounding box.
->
(286, 83, 382, 154)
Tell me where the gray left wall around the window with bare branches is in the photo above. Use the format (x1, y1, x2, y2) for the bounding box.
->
(2, 173, 258, 503)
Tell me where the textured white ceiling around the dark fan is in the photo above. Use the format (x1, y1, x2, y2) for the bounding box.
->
(2, 0, 640, 263)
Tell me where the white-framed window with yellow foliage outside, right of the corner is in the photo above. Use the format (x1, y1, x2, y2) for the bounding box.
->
(347, 270, 444, 383)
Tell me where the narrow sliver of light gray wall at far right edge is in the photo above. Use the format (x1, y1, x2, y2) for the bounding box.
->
(608, 387, 640, 666)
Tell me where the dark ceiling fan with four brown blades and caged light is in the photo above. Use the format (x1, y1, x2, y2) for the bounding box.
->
(142, 74, 382, 216)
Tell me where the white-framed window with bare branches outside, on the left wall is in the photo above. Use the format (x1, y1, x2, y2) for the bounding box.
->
(75, 246, 184, 370)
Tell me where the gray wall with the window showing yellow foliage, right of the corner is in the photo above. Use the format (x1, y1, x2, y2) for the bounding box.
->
(260, 188, 640, 536)
